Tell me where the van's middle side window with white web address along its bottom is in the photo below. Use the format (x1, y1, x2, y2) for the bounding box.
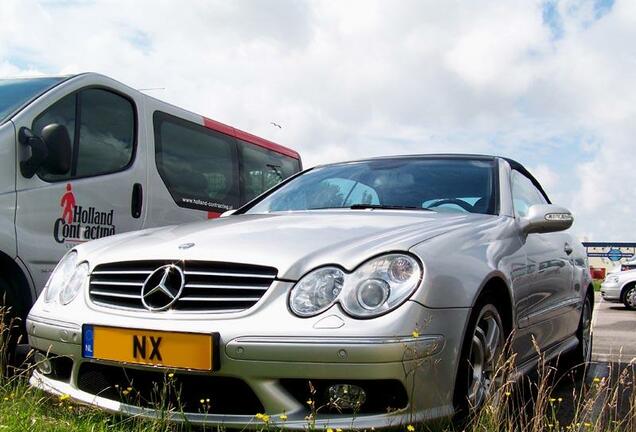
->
(153, 112, 240, 213)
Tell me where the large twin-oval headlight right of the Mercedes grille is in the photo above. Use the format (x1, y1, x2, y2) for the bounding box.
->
(289, 253, 422, 318)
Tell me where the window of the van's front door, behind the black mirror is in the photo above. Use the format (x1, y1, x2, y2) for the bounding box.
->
(32, 89, 136, 182)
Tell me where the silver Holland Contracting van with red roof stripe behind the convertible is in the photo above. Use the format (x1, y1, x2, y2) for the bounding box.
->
(0, 73, 301, 328)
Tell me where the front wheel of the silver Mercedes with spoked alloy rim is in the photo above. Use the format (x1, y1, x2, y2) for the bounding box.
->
(454, 297, 506, 421)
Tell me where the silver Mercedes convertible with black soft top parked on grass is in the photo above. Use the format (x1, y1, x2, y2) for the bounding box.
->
(27, 155, 593, 429)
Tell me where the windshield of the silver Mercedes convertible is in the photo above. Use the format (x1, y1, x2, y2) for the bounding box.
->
(246, 157, 496, 214)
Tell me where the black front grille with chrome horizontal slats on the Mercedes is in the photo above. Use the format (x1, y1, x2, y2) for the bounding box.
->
(89, 261, 277, 312)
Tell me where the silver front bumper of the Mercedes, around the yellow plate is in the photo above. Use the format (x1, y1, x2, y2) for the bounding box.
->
(27, 284, 470, 429)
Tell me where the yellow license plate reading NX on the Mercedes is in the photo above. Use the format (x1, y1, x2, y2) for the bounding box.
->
(82, 325, 218, 370)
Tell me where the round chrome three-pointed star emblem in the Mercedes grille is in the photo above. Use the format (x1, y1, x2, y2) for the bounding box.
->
(141, 264, 185, 311)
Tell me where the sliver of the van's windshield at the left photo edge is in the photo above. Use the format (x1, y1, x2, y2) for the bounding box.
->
(0, 77, 64, 123)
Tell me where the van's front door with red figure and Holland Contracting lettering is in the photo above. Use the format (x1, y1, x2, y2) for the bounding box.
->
(13, 77, 146, 292)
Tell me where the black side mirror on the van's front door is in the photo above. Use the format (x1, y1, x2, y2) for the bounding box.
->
(18, 123, 72, 178)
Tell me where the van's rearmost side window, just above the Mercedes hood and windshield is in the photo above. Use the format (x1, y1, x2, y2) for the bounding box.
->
(238, 139, 300, 202)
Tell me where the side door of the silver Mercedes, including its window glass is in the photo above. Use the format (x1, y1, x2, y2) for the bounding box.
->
(511, 170, 577, 350)
